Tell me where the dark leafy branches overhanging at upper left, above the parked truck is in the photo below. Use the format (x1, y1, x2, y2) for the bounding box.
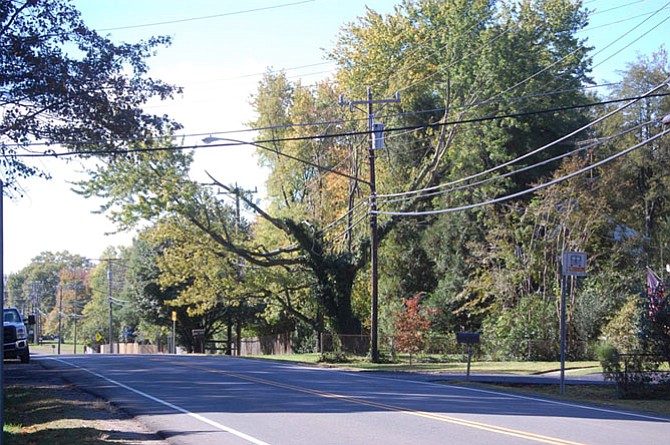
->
(0, 0, 179, 187)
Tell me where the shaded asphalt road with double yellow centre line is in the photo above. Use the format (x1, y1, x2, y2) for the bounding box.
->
(38, 355, 670, 445)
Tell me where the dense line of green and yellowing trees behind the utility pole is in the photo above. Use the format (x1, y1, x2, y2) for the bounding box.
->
(2, 0, 670, 359)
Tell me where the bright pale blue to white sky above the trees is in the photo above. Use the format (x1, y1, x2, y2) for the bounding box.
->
(4, 0, 670, 272)
